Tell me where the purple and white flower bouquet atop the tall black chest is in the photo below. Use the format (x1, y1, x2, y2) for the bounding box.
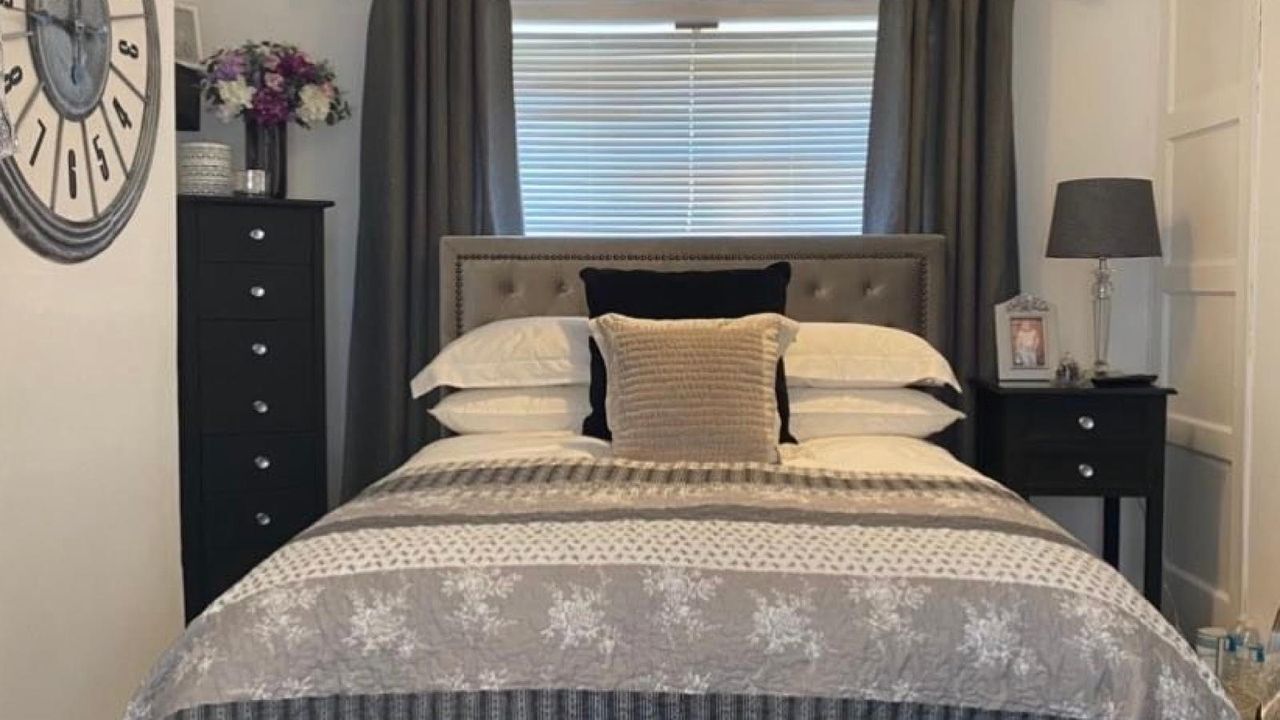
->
(202, 42, 351, 128)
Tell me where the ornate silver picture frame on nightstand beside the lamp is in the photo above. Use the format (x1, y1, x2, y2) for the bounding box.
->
(995, 295, 1060, 382)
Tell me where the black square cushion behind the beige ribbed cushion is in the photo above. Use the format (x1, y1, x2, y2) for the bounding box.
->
(579, 263, 796, 442)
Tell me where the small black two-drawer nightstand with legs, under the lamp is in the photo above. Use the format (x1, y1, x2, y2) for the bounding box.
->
(973, 379, 1176, 607)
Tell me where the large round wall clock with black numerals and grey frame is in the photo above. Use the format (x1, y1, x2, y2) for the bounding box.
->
(0, 0, 160, 263)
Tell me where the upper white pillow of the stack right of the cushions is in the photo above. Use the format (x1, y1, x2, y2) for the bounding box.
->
(785, 323, 960, 389)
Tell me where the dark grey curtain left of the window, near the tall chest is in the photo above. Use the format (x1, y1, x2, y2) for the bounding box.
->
(342, 0, 524, 500)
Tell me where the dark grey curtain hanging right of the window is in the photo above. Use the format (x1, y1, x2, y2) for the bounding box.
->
(863, 0, 1018, 459)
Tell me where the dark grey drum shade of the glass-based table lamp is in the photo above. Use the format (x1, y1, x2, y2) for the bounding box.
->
(1046, 178, 1160, 258)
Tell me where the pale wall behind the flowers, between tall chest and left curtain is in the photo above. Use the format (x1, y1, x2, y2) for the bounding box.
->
(178, 0, 371, 497)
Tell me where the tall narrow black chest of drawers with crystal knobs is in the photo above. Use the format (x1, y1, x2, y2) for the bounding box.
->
(178, 196, 332, 620)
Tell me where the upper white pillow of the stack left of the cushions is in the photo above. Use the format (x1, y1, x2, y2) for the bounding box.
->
(410, 318, 591, 397)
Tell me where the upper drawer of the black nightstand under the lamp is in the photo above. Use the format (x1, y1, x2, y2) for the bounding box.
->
(1011, 397, 1162, 442)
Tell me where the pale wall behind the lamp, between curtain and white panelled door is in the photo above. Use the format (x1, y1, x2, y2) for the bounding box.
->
(1014, 0, 1160, 583)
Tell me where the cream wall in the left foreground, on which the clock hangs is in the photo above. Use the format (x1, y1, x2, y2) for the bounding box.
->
(0, 0, 182, 720)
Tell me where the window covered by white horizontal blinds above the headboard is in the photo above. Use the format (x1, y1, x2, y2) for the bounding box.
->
(515, 6, 876, 234)
